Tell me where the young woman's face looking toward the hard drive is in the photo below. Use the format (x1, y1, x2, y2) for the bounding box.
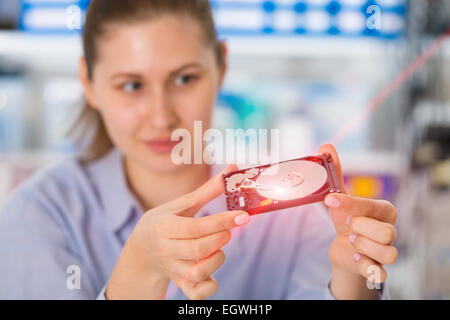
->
(82, 16, 225, 172)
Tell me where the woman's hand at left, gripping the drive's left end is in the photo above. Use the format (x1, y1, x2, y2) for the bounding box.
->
(105, 165, 250, 299)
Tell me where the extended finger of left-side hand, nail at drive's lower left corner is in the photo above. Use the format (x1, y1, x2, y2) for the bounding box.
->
(160, 210, 250, 239)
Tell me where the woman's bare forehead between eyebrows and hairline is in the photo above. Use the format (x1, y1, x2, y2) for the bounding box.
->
(97, 16, 213, 72)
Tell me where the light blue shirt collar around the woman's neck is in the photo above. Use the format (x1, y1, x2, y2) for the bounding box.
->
(88, 148, 227, 231)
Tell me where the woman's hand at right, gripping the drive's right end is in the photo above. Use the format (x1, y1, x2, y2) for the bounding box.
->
(319, 145, 398, 299)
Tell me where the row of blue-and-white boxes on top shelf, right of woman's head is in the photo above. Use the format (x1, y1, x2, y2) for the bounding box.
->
(211, 0, 408, 39)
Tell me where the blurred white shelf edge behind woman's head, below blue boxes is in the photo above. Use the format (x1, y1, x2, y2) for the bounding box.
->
(0, 31, 404, 71)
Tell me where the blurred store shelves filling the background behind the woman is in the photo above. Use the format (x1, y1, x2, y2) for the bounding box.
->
(0, 0, 450, 299)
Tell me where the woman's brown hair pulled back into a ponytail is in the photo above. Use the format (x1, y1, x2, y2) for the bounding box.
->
(69, 0, 224, 161)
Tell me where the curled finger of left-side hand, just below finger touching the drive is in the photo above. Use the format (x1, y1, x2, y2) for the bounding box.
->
(165, 230, 231, 260)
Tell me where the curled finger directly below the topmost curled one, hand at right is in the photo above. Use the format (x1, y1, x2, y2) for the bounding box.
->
(348, 217, 397, 245)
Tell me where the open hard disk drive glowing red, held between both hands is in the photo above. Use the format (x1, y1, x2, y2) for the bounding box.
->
(223, 154, 341, 215)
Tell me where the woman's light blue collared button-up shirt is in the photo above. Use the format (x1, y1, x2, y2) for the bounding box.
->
(0, 149, 387, 299)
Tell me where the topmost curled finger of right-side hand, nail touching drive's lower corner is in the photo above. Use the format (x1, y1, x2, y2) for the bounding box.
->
(324, 193, 397, 225)
